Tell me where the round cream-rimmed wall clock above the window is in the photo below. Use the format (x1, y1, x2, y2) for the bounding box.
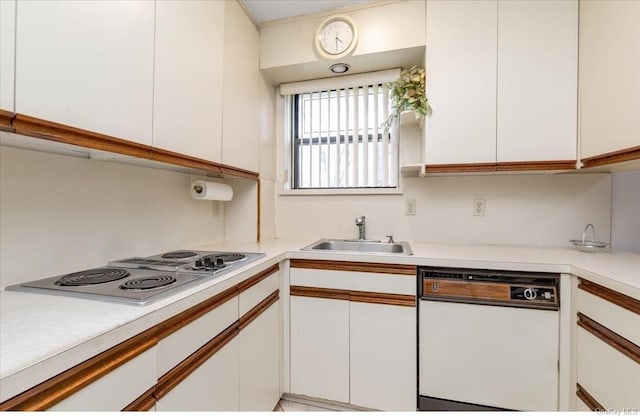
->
(315, 15, 358, 59)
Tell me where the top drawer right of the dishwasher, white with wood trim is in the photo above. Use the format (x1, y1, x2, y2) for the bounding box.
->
(577, 280, 640, 345)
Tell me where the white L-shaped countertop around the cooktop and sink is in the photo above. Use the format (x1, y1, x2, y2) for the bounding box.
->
(0, 240, 640, 402)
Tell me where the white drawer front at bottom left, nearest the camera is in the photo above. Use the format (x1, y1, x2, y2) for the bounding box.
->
(47, 347, 157, 412)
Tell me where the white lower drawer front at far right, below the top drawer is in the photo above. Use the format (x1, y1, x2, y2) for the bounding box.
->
(577, 327, 640, 409)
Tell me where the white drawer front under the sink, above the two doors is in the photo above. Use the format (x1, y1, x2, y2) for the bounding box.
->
(290, 267, 416, 295)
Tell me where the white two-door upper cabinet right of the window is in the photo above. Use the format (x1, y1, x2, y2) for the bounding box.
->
(423, 0, 578, 165)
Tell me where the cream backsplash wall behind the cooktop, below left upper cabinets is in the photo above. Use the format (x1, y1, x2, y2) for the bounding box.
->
(0, 147, 224, 287)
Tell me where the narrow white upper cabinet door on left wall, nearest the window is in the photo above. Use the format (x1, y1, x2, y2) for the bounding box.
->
(222, 1, 260, 172)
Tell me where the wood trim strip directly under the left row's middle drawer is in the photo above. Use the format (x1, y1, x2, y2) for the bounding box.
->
(154, 321, 240, 400)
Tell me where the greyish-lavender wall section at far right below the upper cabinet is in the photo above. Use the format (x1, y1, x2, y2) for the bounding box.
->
(611, 170, 640, 253)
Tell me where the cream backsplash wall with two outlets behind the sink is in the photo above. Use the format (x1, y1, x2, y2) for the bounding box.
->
(276, 174, 611, 246)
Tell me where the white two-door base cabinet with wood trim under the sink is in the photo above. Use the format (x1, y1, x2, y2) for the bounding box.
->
(290, 261, 417, 411)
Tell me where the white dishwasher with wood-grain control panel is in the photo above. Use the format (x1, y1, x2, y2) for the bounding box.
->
(417, 266, 560, 411)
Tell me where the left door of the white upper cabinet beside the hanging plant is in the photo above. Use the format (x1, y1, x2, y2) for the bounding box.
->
(424, 0, 498, 164)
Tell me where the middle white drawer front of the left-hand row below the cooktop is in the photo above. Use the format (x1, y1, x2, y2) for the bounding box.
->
(157, 296, 238, 378)
